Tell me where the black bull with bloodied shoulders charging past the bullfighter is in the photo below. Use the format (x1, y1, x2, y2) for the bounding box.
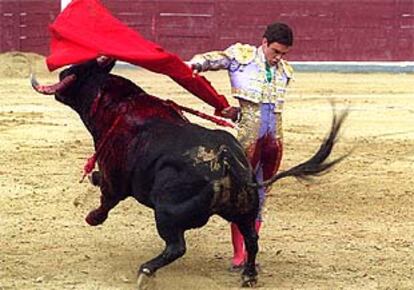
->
(32, 61, 346, 286)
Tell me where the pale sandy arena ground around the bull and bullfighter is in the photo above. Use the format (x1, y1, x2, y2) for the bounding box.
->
(0, 53, 414, 290)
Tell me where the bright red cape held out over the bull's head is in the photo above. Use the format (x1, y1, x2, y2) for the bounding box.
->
(46, 0, 229, 111)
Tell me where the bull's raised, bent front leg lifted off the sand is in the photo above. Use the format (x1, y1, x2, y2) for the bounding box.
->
(85, 184, 123, 226)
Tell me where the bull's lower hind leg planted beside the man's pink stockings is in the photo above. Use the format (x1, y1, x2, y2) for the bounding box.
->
(237, 220, 259, 287)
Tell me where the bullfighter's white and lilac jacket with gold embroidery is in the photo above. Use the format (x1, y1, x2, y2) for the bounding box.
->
(188, 43, 293, 112)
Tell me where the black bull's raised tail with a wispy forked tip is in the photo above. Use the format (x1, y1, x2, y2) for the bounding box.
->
(249, 110, 350, 188)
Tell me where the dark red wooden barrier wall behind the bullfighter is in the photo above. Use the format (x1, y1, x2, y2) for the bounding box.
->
(0, 0, 414, 61)
